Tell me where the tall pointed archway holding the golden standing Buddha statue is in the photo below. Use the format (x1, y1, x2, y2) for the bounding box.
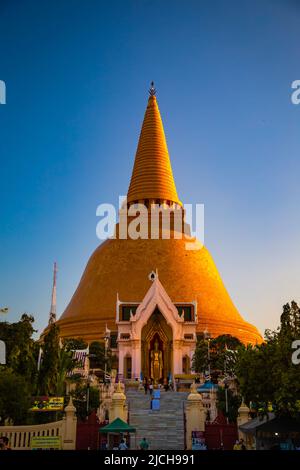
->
(141, 307, 173, 383)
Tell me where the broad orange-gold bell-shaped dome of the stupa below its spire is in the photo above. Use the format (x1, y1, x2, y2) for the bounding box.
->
(59, 239, 262, 343)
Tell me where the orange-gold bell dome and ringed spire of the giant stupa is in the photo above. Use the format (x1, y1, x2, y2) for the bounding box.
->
(57, 87, 262, 344)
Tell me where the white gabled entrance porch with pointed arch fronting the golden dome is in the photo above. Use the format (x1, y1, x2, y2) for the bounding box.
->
(116, 273, 197, 383)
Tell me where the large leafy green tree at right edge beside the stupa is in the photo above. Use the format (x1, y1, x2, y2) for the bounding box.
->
(235, 302, 300, 418)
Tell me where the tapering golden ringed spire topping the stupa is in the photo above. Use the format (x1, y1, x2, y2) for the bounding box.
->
(127, 82, 181, 204)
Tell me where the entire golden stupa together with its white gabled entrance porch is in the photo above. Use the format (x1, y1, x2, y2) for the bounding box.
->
(57, 85, 262, 382)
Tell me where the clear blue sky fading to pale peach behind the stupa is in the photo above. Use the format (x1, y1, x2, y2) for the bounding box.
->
(0, 0, 300, 338)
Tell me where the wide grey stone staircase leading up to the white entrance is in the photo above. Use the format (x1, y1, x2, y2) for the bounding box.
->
(126, 388, 188, 450)
